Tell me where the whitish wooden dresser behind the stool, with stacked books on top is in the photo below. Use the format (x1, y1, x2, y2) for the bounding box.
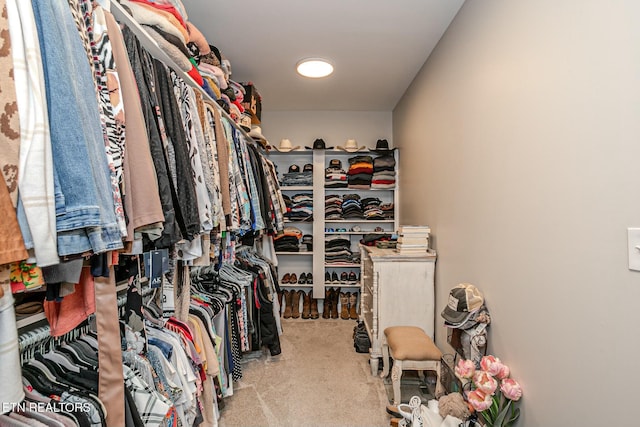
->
(360, 245, 436, 375)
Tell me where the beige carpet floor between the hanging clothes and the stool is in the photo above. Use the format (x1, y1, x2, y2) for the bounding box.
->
(219, 319, 390, 427)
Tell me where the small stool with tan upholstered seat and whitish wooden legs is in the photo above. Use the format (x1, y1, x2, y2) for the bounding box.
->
(381, 326, 444, 405)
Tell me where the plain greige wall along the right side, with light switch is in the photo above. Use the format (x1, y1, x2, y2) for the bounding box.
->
(393, 0, 640, 427)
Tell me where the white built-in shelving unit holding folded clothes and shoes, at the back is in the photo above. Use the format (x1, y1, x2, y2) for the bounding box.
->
(269, 149, 400, 318)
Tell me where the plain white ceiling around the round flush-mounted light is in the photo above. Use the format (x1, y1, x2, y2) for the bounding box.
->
(183, 0, 464, 111)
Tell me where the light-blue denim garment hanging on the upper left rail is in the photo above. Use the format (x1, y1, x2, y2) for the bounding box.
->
(32, 0, 122, 255)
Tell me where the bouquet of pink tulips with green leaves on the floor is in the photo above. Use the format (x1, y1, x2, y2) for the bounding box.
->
(455, 356, 522, 427)
